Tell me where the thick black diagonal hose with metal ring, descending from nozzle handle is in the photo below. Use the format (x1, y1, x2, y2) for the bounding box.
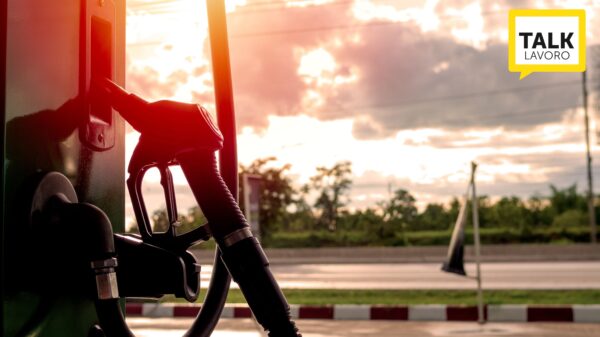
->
(177, 151, 299, 337)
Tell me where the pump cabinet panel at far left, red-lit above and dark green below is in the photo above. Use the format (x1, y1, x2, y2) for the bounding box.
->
(0, 0, 125, 337)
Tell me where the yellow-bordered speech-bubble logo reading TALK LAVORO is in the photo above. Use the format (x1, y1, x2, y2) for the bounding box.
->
(508, 9, 586, 79)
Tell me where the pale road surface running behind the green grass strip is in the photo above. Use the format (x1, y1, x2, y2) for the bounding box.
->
(202, 261, 600, 289)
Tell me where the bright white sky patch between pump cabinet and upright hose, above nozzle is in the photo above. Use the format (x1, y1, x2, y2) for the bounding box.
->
(127, 0, 212, 101)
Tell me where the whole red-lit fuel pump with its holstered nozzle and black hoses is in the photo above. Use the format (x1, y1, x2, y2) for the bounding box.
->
(0, 0, 298, 337)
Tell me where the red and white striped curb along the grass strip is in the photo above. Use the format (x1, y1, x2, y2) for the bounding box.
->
(126, 303, 600, 323)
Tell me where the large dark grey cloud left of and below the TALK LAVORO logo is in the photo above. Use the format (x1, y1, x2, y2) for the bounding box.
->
(332, 30, 580, 131)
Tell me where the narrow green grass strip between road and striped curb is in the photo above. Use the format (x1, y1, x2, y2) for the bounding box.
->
(162, 289, 600, 305)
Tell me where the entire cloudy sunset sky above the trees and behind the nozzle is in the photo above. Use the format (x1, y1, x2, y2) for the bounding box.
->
(126, 0, 600, 222)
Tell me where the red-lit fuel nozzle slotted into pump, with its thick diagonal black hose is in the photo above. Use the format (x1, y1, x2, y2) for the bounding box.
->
(103, 80, 300, 337)
